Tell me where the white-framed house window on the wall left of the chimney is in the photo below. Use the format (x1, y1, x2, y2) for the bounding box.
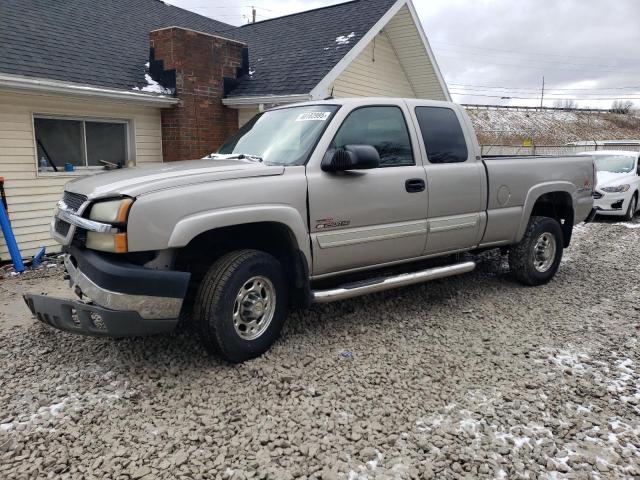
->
(33, 116, 128, 172)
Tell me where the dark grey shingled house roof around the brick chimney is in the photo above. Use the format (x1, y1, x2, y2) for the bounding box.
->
(0, 0, 424, 97)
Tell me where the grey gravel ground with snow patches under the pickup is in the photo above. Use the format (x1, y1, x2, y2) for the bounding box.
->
(0, 218, 640, 480)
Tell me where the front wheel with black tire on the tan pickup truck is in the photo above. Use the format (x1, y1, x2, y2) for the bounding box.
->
(193, 250, 289, 363)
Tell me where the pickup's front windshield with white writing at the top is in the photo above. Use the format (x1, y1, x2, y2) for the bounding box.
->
(218, 105, 338, 165)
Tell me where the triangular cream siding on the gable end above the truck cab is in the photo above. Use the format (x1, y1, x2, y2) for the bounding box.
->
(333, 30, 416, 98)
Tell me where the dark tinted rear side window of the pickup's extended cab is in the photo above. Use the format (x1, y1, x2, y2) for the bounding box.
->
(416, 107, 469, 163)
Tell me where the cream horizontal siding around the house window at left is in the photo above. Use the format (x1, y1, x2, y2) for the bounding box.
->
(0, 92, 162, 260)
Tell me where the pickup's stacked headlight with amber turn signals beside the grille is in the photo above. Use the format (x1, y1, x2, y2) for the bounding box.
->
(87, 198, 133, 253)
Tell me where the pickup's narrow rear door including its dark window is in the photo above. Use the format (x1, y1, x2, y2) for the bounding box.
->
(410, 102, 487, 255)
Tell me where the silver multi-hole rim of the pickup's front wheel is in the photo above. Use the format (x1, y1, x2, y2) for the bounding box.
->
(233, 276, 276, 340)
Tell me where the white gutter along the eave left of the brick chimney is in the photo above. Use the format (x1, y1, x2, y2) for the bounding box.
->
(0, 73, 178, 108)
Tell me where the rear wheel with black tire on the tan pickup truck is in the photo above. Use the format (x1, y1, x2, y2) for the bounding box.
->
(509, 217, 563, 286)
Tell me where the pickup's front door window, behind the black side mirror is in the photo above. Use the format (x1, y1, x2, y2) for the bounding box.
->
(331, 107, 415, 167)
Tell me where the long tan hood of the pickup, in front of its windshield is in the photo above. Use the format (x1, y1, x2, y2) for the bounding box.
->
(65, 159, 284, 200)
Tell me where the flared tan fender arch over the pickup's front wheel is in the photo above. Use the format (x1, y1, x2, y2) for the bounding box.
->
(168, 204, 311, 265)
